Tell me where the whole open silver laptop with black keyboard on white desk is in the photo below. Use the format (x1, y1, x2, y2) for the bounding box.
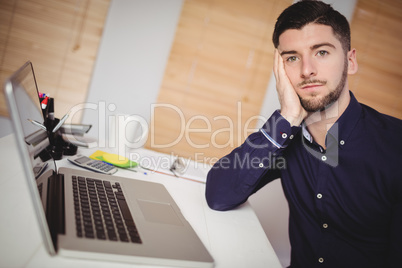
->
(4, 62, 214, 267)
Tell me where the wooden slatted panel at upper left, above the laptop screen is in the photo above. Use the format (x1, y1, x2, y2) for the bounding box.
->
(0, 0, 110, 122)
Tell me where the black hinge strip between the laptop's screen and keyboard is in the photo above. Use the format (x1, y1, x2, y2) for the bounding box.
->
(46, 174, 65, 251)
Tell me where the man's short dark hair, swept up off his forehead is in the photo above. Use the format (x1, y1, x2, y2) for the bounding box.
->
(272, 0, 350, 53)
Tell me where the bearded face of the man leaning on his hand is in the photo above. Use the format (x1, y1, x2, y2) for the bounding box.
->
(278, 23, 348, 112)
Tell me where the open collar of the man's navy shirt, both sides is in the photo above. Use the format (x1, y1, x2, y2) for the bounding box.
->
(302, 91, 362, 145)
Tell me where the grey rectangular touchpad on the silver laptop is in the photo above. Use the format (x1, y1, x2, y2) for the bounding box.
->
(137, 199, 183, 225)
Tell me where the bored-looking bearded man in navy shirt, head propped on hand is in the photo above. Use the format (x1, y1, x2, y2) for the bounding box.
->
(206, 1, 402, 268)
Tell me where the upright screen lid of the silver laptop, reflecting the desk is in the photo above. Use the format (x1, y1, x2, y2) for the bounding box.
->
(4, 62, 56, 254)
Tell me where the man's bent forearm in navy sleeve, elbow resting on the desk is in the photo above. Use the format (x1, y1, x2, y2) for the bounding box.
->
(206, 112, 299, 210)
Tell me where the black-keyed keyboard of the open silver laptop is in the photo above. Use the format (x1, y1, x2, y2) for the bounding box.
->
(72, 176, 142, 243)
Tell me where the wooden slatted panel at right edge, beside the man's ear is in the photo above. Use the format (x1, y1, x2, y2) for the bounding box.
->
(349, 0, 402, 119)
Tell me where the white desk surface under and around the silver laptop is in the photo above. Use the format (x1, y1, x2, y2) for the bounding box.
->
(0, 135, 281, 268)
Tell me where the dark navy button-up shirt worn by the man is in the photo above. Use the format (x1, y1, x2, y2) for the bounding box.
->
(206, 93, 402, 268)
